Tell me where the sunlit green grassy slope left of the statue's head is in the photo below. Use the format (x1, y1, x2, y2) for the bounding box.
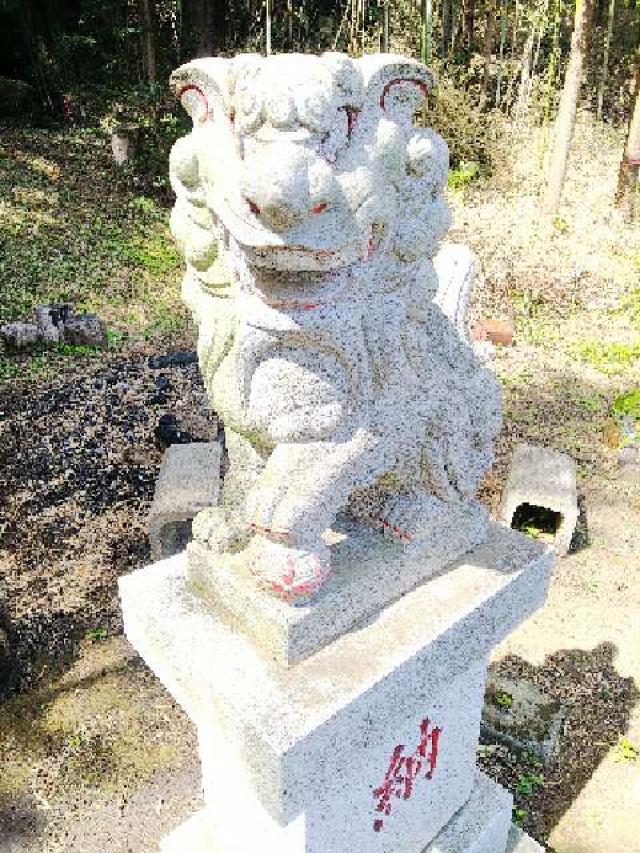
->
(0, 128, 186, 340)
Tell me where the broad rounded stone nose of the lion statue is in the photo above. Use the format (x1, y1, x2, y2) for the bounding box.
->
(240, 143, 311, 231)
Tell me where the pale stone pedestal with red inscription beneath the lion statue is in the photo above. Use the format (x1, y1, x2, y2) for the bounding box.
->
(120, 526, 552, 853)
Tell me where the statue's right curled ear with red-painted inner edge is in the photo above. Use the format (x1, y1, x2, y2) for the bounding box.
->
(357, 53, 436, 125)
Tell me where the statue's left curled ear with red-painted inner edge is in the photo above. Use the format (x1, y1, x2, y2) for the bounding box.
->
(169, 57, 229, 126)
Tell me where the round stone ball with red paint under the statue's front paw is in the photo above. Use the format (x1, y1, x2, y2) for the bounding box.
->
(249, 535, 331, 602)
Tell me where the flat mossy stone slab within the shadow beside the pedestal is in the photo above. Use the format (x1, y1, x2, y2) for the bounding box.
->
(482, 671, 564, 763)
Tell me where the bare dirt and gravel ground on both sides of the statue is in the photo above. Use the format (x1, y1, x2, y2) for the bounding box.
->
(0, 115, 640, 853)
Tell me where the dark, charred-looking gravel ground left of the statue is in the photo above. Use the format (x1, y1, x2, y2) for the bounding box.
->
(0, 352, 217, 694)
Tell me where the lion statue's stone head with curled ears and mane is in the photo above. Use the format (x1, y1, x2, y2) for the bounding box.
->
(172, 53, 448, 271)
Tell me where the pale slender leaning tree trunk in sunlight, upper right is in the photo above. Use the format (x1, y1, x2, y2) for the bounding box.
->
(543, 0, 592, 213)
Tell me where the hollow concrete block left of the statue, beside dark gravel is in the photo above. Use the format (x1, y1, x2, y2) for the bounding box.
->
(149, 442, 221, 560)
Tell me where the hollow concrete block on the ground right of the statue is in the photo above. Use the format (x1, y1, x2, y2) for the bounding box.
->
(498, 444, 579, 556)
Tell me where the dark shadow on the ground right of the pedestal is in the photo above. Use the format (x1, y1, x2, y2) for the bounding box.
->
(479, 643, 640, 842)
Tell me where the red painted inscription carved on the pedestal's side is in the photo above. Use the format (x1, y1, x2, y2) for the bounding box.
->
(373, 717, 442, 832)
